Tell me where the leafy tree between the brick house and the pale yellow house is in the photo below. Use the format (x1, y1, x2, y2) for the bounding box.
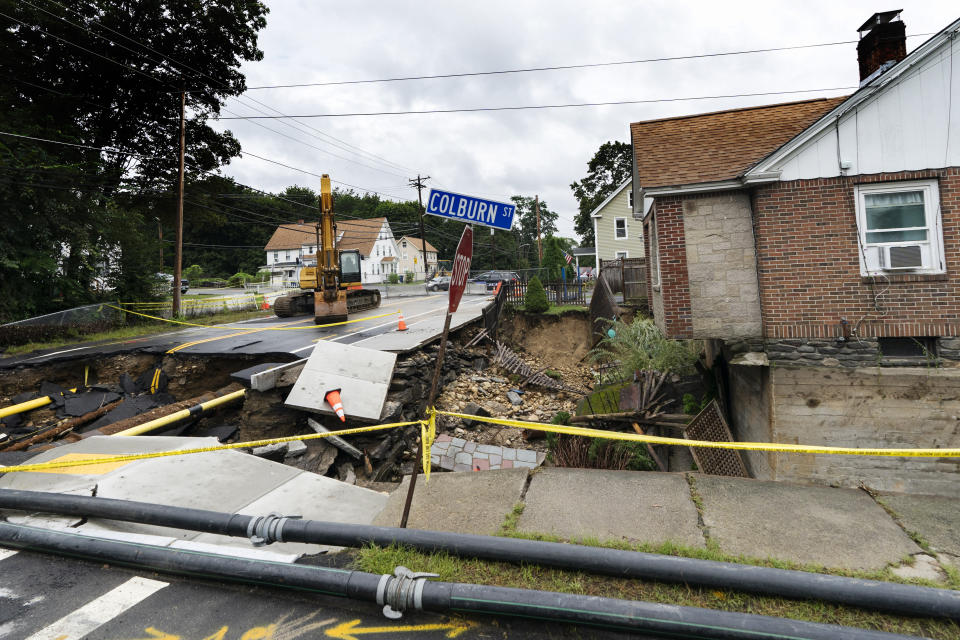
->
(570, 142, 633, 247)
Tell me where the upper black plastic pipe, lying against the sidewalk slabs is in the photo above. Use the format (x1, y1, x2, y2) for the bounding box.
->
(0, 489, 960, 620)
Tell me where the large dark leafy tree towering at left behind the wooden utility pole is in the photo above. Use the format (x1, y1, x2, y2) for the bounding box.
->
(0, 0, 267, 319)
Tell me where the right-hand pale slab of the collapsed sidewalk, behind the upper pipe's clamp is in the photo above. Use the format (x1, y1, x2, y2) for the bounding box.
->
(194, 472, 389, 554)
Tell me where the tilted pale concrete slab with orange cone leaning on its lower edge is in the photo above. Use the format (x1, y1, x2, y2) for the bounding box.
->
(285, 341, 397, 421)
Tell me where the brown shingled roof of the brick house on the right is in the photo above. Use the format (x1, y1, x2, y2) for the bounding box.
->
(630, 96, 846, 189)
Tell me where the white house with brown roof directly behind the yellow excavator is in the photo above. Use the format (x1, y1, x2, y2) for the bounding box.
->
(264, 218, 399, 286)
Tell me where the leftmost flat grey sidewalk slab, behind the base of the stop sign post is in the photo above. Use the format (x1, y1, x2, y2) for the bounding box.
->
(373, 469, 528, 535)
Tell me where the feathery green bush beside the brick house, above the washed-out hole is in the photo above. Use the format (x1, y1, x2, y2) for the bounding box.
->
(590, 317, 700, 378)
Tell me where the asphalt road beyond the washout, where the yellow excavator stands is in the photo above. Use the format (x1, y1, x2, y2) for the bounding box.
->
(0, 292, 489, 369)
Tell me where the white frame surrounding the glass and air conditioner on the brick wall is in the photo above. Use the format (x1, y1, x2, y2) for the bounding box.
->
(854, 180, 946, 276)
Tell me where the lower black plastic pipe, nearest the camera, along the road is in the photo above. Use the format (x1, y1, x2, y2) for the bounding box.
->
(0, 522, 928, 640)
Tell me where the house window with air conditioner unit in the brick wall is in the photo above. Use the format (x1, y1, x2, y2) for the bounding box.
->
(855, 180, 945, 275)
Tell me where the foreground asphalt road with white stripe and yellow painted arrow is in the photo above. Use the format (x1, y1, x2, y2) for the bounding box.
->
(0, 548, 627, 640)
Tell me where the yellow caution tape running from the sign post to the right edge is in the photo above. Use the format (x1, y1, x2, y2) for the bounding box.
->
(436, 411, 960, 458)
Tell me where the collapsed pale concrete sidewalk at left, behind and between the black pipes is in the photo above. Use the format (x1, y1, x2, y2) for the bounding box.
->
(0, 436, 388, 562)
